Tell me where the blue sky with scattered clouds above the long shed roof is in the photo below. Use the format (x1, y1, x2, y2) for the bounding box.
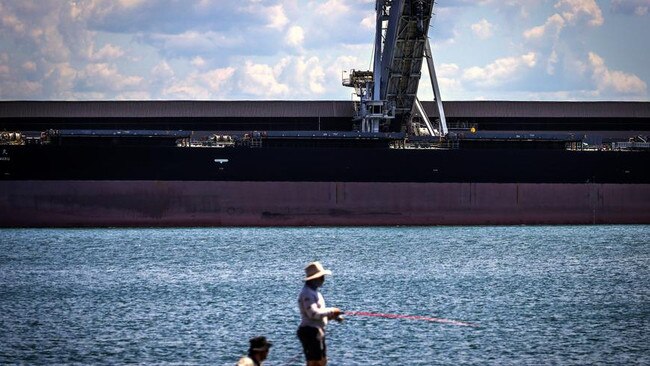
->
(0, 0, 650, 101)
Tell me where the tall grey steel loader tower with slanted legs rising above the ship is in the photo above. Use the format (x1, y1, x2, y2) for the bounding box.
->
(343, 0, 447, 136)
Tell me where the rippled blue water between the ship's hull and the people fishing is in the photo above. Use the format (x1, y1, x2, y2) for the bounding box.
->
(0, 226, 650, 365)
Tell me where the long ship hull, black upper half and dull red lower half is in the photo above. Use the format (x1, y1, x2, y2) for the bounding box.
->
(0, 145, 650, 227)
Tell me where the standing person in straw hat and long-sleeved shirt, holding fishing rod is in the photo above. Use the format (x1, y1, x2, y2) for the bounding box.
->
(298, 262, 342, 366)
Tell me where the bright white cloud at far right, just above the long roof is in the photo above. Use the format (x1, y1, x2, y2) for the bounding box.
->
(589, 52, 647, 96)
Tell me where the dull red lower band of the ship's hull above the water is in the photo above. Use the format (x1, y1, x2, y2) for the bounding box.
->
(0, 181, 650, 227)
